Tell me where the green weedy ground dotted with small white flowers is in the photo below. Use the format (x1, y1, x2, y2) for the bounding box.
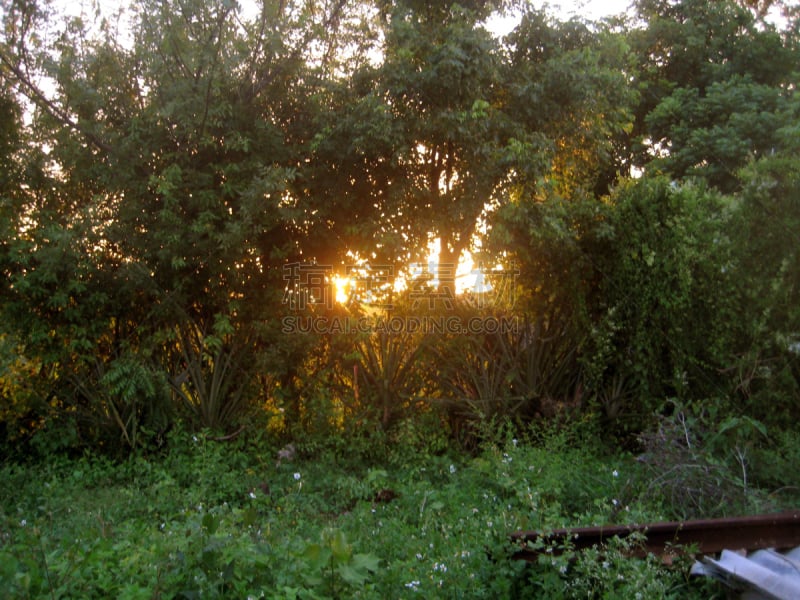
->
(0, 424, 780, 599)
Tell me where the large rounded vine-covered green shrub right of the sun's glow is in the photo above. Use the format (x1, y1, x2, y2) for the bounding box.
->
(496, 177, 740, 431)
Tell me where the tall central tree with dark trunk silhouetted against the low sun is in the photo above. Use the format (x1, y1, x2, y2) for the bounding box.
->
(304, 2, 509, 288)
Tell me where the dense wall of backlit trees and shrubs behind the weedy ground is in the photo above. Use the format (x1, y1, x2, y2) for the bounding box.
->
(0, 0, 800, 448)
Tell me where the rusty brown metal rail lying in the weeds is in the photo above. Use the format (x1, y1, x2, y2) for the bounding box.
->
(511, 510, 800, 561)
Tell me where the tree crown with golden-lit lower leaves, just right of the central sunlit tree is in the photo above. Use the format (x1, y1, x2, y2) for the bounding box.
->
(504, 10, 638, 198)
